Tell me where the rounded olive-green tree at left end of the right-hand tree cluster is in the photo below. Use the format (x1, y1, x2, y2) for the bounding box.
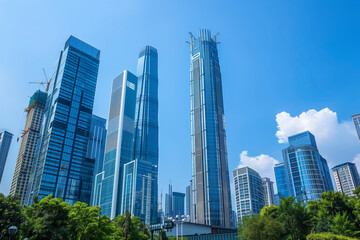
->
(239, 215, 285, 240)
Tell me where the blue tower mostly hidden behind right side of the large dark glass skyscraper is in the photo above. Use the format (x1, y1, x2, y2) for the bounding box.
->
(87, 115, 106, 206)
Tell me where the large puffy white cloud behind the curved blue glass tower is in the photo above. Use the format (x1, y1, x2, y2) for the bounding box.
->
(276, 108, 360, 171)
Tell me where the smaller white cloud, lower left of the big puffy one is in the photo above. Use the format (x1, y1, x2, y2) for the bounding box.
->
(238, 151, 279, 187)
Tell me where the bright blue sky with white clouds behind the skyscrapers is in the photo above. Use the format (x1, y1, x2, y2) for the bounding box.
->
(0, 0, 360, 206)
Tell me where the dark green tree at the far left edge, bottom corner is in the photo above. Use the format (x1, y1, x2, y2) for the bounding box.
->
(0, 193, 24, 238)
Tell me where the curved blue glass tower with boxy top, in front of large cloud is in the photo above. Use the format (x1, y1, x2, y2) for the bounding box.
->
(283, 131, 333, 202)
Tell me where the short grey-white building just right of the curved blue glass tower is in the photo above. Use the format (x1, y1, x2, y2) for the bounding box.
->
(332, 162, 360, 196)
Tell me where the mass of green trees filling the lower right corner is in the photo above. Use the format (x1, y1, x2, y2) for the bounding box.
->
(238, 187, 360, 240)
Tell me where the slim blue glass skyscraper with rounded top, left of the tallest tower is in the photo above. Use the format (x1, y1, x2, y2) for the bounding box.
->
(133, 46, 159, 225)
